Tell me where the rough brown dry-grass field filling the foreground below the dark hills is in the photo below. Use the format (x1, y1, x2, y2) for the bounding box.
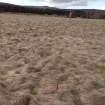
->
(0, 13, 105, 105)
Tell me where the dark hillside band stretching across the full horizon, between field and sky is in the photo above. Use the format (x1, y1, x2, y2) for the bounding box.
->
(0, 2, 105, 19)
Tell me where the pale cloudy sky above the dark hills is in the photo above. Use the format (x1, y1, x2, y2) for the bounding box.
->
(0, 0, 105, 10)
